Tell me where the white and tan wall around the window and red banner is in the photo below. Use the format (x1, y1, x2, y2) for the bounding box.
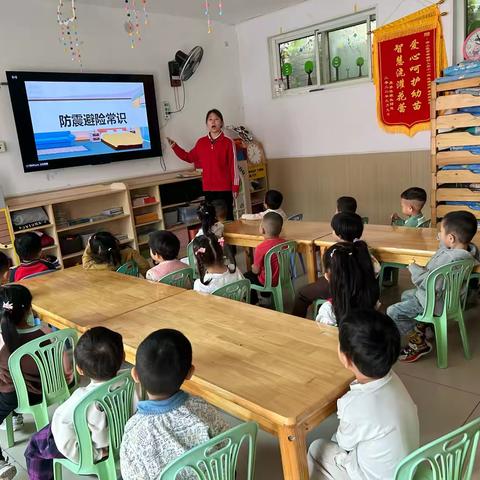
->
(237, 0, 454, 223)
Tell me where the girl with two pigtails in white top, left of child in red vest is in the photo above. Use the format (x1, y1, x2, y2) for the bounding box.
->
(193, 233, 243, 293)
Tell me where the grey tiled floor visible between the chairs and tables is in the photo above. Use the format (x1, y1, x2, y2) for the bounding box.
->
(0, 272, 480, 480)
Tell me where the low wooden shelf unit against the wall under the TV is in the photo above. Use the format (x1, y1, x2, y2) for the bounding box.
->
(4, 171, 201, 267)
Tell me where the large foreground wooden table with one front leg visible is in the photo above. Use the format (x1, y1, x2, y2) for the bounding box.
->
(83, 291, 353, 480)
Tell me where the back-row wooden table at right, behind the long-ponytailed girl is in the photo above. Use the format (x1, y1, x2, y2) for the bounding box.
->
(315, 225, 480, 271)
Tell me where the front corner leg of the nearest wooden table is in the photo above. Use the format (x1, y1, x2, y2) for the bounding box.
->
(278, 425, 308, 480)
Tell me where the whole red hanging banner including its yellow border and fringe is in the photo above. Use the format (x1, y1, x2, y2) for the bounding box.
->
(373, 5, 447, 136)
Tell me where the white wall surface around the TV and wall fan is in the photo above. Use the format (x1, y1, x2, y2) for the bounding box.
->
(0, 0, 243, 196)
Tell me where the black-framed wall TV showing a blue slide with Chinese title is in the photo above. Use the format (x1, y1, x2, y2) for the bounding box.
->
(6, 72, 162, 172)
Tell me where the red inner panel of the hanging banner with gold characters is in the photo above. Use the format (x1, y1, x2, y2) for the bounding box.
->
(378, 29, 436, 129)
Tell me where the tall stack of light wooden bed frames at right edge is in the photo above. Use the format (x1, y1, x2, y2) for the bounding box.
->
(430, 76, 480, 225)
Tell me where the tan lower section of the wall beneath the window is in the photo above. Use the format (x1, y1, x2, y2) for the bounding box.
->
(269, 151, 431, 224)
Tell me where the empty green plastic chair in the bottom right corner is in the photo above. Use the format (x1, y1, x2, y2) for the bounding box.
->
(395, 418, 480, 480)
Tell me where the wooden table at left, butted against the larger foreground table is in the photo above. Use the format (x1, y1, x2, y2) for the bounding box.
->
(20, 266, 185, 331)
